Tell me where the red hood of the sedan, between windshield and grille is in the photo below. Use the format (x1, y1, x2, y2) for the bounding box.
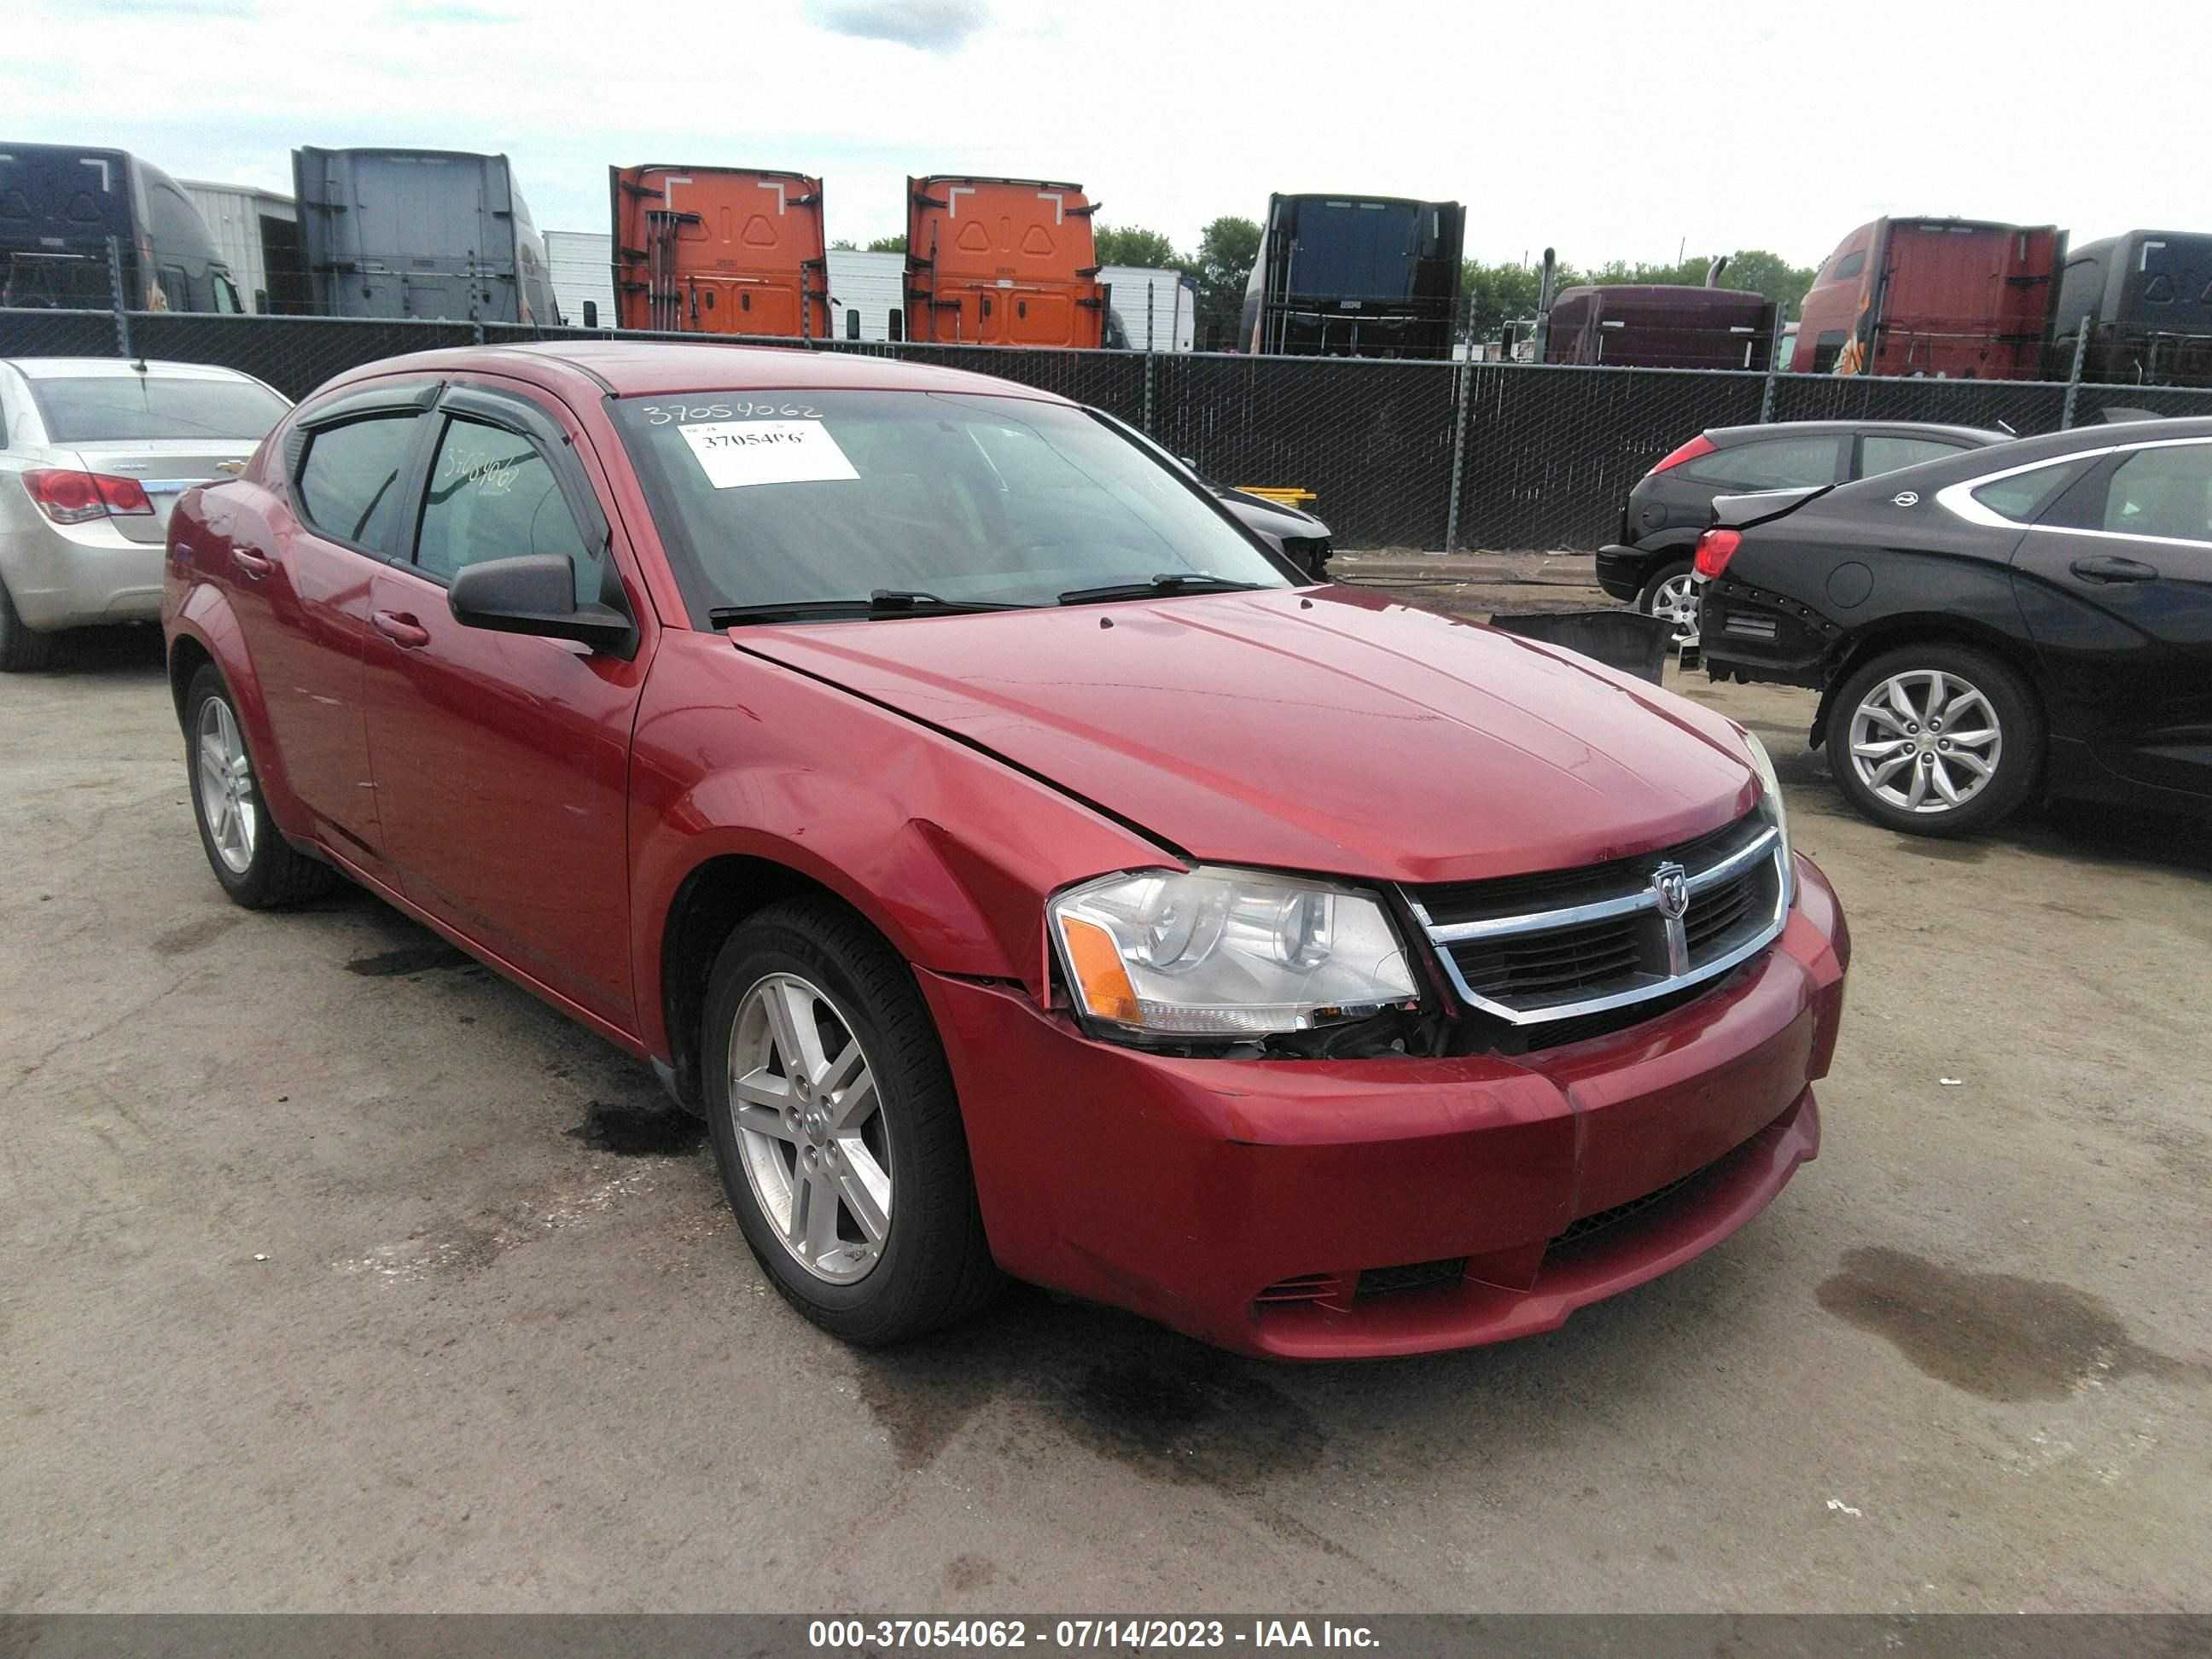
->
(730, 588, 1759, 882)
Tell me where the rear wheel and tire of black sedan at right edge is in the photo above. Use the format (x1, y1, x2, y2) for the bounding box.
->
(1827, 639, 2044, 836)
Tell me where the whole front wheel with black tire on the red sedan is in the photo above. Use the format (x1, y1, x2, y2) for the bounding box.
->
(699, 898, 1000, 1348)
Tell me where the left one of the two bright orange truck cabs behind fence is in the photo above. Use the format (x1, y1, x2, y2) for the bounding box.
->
(608, 166, 830, 339)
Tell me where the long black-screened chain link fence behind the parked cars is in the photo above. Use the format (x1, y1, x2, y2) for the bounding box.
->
(0, 310, 2212, 550)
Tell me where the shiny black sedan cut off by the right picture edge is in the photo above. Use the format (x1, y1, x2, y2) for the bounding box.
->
(1697, 418, 2212, 836)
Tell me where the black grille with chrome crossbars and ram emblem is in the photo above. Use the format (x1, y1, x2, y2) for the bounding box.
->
(1407, 812, 1790, 1024)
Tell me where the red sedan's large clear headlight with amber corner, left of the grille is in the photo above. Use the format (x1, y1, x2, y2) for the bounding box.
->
(1046, 867, 1417, 1038)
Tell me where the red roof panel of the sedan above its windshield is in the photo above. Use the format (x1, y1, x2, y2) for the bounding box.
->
(332, 341, 1071, 403)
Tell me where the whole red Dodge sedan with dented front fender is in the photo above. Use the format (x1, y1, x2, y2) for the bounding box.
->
(164, 343, 1849, 1358)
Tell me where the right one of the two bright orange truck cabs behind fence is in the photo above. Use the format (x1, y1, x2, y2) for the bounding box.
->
(907, 172, 1106, 345)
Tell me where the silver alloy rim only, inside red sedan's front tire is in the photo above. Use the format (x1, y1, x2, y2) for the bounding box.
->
(730, 973, 892, 1285)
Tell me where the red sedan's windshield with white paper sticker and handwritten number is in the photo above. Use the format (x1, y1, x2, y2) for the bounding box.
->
(610, 392, 1292, 626)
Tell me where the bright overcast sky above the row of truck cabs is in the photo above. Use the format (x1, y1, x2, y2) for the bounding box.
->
(0, 0, 2212, 265)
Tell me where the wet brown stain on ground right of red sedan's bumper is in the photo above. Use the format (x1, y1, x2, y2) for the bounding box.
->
(1819, 1248, 2212, 1402)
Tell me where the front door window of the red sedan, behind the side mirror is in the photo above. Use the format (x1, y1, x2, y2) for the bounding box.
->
(416, 418, 604, 604)
